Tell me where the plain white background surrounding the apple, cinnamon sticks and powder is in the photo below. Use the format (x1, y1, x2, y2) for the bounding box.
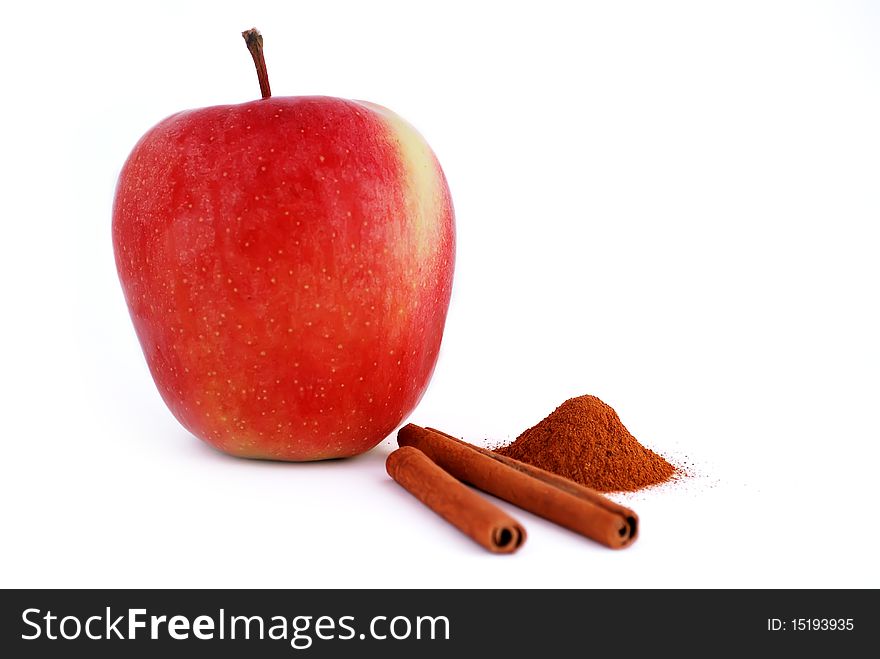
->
(0, 1, 880, 587)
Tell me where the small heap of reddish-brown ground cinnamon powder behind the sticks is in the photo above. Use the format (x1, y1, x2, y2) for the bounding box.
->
(495, 396, 676, 492)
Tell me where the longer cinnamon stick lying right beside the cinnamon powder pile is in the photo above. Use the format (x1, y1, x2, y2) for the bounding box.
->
(397, 424, 638, 549)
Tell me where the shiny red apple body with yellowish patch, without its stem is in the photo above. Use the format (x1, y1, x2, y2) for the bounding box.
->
(113, 96, 455, 461)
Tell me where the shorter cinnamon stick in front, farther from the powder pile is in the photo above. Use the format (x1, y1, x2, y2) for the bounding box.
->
(385, 446, 526, 554)
